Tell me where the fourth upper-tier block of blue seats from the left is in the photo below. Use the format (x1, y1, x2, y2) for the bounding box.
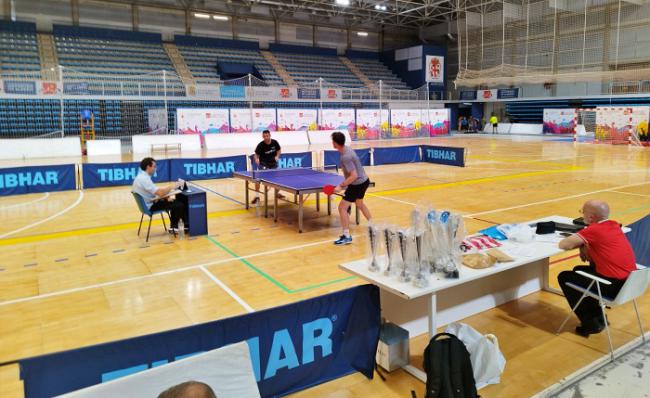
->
(273, 51, 364, 87)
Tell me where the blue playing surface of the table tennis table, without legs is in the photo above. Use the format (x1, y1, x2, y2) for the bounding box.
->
(235, 169, 344, 191)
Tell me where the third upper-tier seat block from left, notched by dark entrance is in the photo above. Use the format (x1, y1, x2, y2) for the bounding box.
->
(175, 35, 283, 86)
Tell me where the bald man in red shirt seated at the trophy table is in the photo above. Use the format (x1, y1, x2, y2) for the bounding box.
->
(557, 200, 636, 337)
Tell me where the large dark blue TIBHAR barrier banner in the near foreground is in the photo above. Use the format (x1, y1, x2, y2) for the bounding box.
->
(20, 285, 381, 398)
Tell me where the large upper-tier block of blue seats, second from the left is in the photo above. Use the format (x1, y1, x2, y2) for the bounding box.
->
(54, 25, 185, 96)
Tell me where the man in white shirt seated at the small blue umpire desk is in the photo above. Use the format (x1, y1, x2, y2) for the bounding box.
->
(132, 158, 188, 233)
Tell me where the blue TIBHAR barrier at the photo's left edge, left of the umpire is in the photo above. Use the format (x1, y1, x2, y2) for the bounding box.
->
(0, 164, 77, 196)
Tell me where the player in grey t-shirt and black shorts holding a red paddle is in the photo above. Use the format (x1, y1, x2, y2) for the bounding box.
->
(332, 131, 372, 245)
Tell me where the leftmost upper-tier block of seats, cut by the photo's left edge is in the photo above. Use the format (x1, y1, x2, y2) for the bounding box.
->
(0, 20, 41, 79)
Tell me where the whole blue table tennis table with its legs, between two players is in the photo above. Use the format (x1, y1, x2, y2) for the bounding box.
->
(233, 168, 375, 232)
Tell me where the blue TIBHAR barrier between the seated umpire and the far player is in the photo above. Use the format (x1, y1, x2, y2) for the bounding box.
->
(170, 155, 246, 181)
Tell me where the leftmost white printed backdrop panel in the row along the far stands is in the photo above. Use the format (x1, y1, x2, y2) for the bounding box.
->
(176, 108, 230, 134)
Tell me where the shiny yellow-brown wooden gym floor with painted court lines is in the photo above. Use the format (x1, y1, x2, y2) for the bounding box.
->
(0, 136, 650, 398)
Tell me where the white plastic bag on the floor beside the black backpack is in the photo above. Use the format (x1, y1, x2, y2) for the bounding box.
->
(445, 323, 506, 389)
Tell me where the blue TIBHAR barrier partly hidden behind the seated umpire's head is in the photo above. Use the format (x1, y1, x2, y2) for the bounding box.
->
(81, 159, 170, 189)
